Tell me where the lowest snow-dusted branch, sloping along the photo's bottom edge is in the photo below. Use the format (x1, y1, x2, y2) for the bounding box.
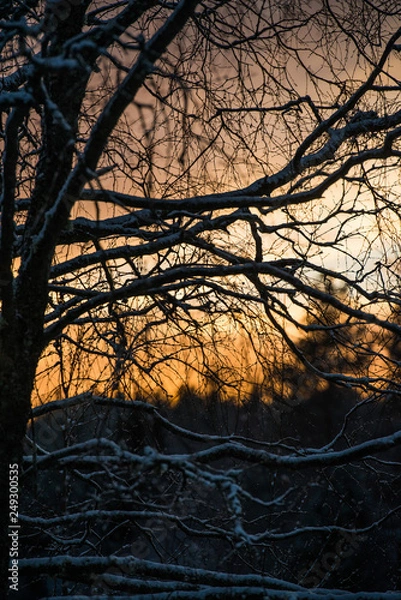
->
(20, 556, 398, 600)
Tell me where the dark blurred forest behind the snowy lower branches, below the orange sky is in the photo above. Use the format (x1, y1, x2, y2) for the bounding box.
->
(21, 385, 401, 597)
